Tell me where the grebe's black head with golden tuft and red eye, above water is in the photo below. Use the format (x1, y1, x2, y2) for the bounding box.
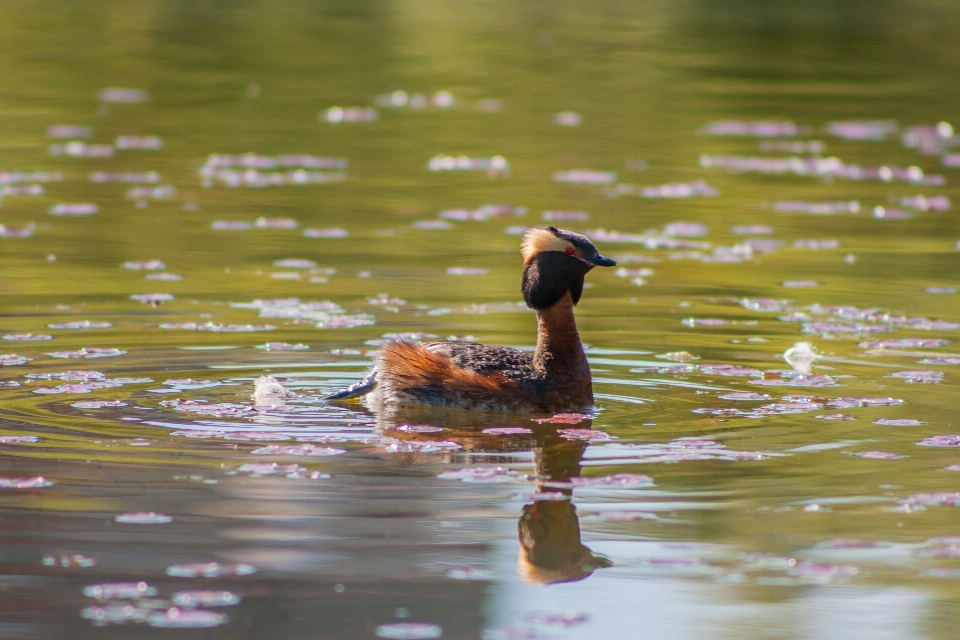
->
(520, 227, 617, 309)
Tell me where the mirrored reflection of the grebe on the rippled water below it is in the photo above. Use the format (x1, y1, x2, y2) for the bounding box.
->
(377, 408, 612, 585)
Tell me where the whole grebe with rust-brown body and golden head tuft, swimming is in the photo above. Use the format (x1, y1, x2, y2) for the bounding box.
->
(325, 227, 617, 411)
